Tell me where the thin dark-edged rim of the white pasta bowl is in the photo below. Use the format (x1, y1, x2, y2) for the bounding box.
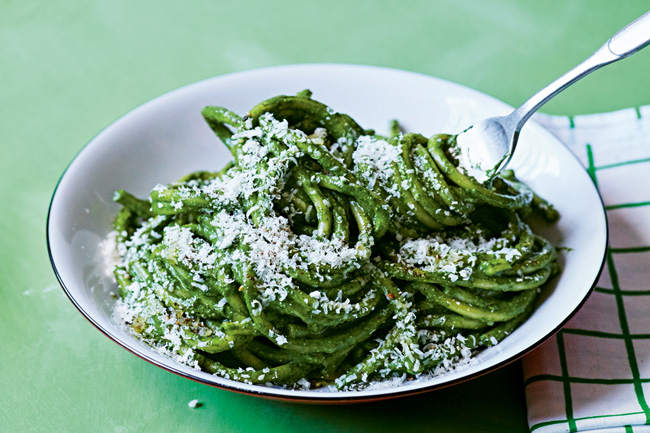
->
(45, 63, 609, 405)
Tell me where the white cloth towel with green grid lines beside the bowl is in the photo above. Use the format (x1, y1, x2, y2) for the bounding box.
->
(523, 106, 650, 433)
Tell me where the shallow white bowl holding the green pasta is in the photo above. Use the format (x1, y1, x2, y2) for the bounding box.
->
(47, 64, 607, 403)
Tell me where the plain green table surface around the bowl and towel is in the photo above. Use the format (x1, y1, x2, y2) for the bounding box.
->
(5, 0, 650, 433)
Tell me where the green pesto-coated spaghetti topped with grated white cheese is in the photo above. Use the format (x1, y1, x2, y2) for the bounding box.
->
(114, 91, 558, 389)
